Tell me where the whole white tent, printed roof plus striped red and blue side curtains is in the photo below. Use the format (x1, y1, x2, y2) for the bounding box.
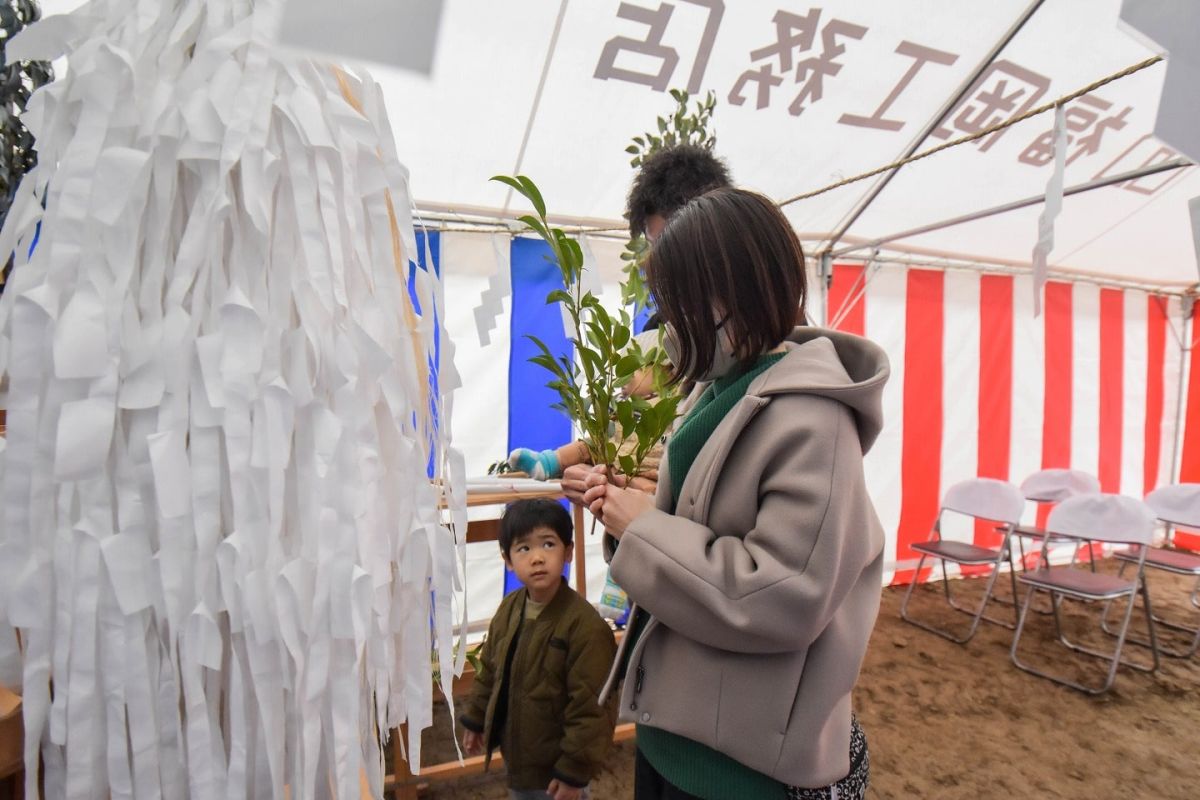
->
(23, 0, 1200, 619)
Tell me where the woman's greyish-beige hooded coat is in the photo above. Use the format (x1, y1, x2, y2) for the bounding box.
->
(605, 327, 888, 787)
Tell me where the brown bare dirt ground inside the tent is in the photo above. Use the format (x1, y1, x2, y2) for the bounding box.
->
(405, 565, 1200, 800)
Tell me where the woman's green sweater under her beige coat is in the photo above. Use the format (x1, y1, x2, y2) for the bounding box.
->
(630, 353, 787, 800)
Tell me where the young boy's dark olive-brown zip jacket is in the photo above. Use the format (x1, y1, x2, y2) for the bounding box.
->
(460, 582, 617, 790)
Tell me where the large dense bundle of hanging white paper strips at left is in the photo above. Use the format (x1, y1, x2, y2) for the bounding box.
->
(0, 0, 466, 800)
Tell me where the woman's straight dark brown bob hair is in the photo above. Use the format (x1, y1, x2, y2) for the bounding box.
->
(646, 188, 808, 381)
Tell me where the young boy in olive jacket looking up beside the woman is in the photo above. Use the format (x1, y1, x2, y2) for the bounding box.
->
(460, 499, 617, 800)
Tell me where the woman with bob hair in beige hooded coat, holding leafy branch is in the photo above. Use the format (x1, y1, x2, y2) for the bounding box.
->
(583, 188, 888, 800)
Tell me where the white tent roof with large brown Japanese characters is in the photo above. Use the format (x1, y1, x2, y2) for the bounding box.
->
(362, 0, 1200, 289)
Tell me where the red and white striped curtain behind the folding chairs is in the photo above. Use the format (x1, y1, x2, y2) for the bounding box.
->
(827, 264, 1180, 583)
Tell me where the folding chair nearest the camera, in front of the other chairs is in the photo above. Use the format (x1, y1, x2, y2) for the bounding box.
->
(1010, 494, 1158, 694)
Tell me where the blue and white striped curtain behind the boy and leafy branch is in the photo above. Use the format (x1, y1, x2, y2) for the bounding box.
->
(439, 233, 624, 620)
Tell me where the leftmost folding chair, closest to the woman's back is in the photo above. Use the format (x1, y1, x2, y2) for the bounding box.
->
(900, 477, 1025, 644)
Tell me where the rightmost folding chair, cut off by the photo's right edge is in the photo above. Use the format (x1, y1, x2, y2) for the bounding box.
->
(1103, 483, 1200, 658)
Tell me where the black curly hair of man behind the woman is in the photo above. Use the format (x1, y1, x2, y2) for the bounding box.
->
(625, 144, 733, 236)
